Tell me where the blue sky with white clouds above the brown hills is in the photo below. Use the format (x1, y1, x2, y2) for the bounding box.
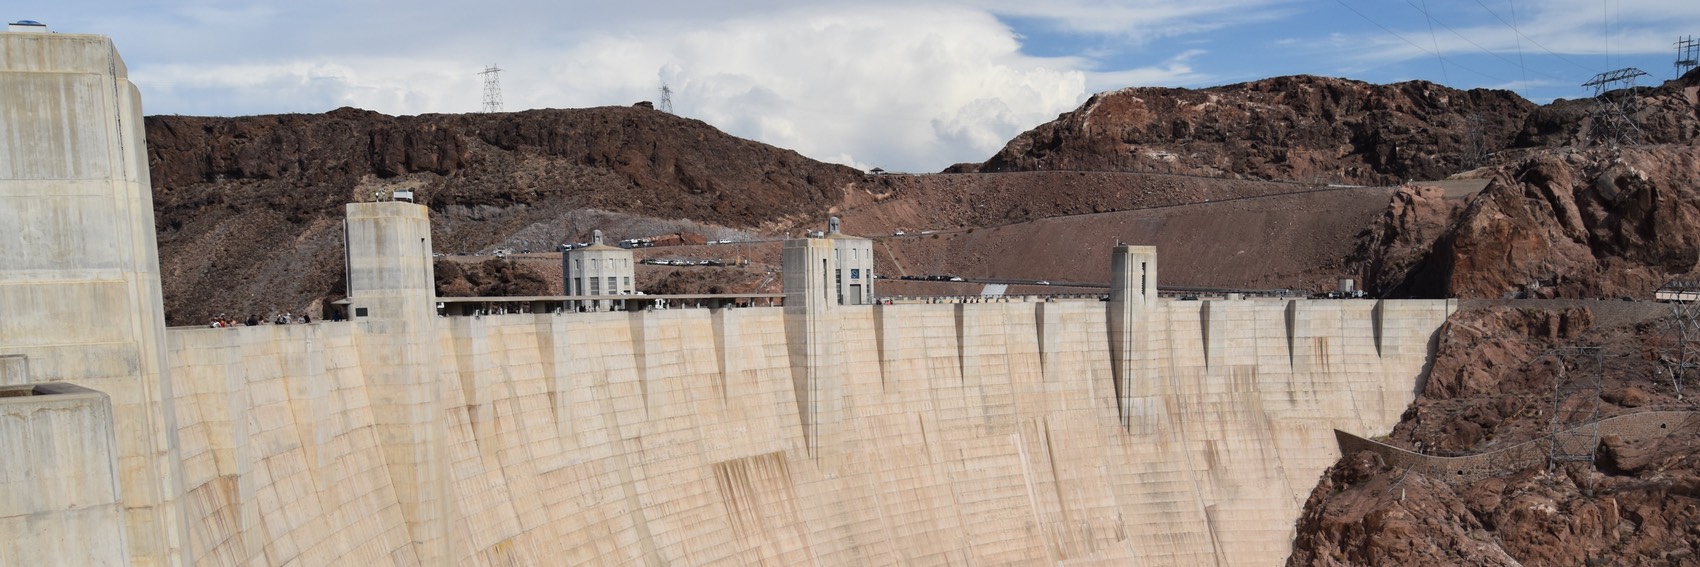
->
(13, 0, 1700, 171)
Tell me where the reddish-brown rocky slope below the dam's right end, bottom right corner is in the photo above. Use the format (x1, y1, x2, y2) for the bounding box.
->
(1287, 302, 1700, 565)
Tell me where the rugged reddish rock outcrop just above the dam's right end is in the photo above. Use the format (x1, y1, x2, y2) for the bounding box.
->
(1350, 144, 1700, 297)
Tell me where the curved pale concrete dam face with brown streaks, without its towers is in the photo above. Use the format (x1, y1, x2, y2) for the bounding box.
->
(170, 300, 1450, 565)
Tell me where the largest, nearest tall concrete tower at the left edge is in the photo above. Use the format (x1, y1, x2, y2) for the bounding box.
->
(0, 32, 190, 565)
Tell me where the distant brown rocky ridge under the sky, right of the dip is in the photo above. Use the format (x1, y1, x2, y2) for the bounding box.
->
(978, 76, 1535, 185)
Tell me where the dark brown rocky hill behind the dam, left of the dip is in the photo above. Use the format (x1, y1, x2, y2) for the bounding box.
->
(146, 105, 860, 324)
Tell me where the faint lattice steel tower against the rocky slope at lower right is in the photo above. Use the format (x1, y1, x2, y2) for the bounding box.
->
(1547, 346, 1605, 492)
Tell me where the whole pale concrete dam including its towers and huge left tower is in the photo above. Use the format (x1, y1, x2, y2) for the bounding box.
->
(0, 32, 1454, 565)
